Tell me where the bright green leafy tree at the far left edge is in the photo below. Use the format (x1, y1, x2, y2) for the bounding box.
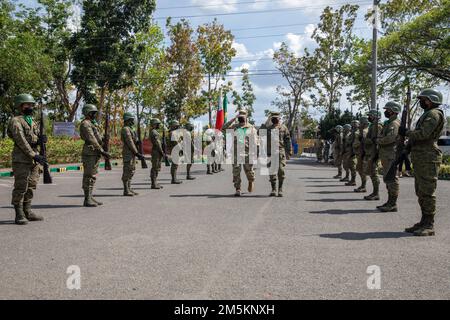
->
(0, 0, 51, 137)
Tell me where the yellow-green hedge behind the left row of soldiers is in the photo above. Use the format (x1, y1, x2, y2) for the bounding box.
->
(0, 137, 122, 168)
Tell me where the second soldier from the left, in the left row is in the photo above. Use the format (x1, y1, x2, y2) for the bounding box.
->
(80, 104, 111, 207)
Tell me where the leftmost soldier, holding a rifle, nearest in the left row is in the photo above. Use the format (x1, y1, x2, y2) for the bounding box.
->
(8, 94, 47, 225)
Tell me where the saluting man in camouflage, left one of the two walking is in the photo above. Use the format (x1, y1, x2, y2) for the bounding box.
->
(222, 110, 258, 197)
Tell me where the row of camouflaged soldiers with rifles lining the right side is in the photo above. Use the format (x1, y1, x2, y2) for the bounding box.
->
(333, 89, 445, 236)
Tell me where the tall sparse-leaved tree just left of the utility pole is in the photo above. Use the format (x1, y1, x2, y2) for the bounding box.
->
(312, 4, 359, 112)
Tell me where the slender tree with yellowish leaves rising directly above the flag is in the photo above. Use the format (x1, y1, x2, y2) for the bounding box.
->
(197, 19, 236, 126)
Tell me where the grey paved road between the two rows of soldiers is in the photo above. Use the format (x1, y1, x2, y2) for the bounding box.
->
(0, 159, 450, 299)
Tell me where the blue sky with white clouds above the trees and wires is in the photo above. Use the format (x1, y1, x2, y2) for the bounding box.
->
(22, 0, 448, 124)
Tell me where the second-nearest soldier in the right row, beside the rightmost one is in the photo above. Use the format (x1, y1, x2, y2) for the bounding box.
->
(377, 101, 402, 212)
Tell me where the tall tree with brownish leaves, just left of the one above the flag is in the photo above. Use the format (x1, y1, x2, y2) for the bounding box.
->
(165, 19, 202, 121)
